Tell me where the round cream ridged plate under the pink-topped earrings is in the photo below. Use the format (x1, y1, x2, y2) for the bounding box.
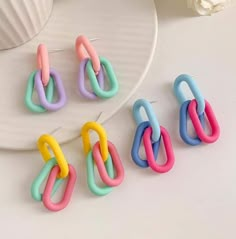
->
(0, 0, 158, 150)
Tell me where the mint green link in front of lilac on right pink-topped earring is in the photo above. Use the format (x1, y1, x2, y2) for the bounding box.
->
(86, 57, 119, 99)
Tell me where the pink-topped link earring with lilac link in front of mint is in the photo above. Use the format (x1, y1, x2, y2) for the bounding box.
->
(25, 44, 66, 113)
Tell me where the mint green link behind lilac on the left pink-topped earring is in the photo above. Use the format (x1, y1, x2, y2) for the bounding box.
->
(25, 70, 54, 113)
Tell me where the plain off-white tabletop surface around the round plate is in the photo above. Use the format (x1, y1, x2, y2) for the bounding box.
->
(0, 0, 236, 239)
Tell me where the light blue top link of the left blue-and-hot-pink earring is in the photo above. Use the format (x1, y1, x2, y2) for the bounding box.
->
(133, 99, 161, 142)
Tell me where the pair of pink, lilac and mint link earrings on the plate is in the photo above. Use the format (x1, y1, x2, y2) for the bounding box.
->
(25, 36, 119, 113)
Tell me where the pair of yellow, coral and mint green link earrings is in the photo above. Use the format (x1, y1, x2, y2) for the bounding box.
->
(31, 122, 124, 211)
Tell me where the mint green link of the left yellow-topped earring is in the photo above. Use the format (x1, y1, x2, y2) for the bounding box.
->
(31, 158, 64, 201)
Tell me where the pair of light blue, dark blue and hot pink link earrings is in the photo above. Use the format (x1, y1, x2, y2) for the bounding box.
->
(131, 75, 220, 173)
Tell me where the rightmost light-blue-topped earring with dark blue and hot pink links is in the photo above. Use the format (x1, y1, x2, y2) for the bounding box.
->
(174, 74, 220, 146)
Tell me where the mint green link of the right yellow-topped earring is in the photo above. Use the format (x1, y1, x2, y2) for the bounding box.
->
(86, 150, 115, 196)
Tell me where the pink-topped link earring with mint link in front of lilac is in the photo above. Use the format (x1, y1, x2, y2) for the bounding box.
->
(75, 36, 119, 100)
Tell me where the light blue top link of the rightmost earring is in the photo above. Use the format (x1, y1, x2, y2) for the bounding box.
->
(174, 74, 205, 115)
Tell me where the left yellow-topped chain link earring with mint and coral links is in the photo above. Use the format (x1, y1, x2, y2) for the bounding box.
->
(31, 135, 77, 211)
